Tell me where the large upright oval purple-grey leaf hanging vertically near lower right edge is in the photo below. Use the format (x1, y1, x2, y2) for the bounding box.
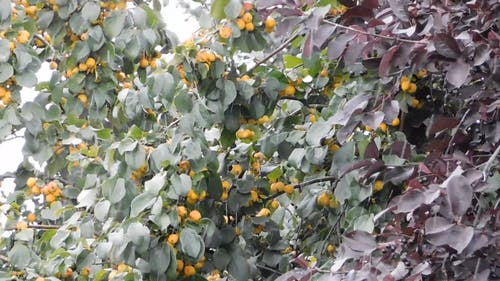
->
(446, 175, 472, 217)
